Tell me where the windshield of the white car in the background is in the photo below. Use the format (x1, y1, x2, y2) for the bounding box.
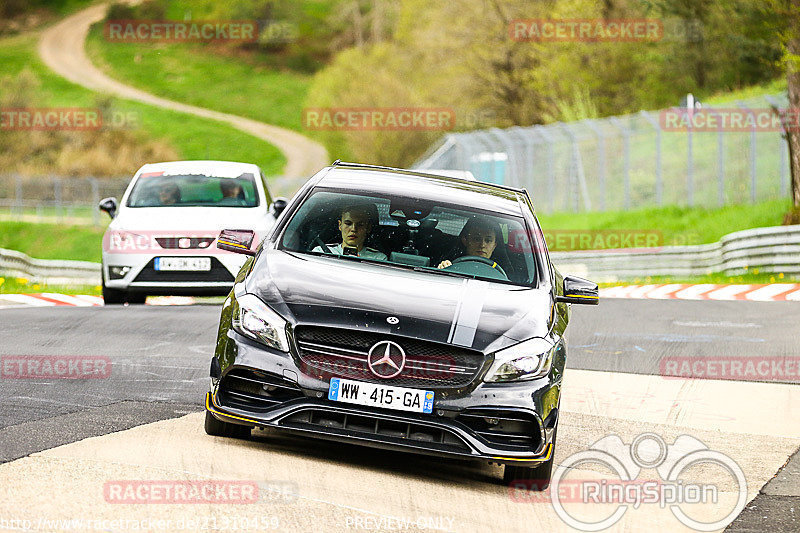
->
(126, 173, 258, 207)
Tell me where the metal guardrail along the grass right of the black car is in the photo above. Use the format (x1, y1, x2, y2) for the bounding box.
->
(550, 225, 800, 282)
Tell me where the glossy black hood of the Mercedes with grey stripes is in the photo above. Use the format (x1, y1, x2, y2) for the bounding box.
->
(246, 249, 550, 353)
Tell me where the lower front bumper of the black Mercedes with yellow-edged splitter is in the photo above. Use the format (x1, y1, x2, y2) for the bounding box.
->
(206, 372, 558, 466)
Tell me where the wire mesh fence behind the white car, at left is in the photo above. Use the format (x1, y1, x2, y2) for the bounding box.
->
(0, 175, 306, 225)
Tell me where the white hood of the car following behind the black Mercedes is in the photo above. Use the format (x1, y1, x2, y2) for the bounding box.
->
(109, 206, 268, 234)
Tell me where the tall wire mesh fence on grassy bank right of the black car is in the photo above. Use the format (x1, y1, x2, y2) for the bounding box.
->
(414, 95, 789, 212)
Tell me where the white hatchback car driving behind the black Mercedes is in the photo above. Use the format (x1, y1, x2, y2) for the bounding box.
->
(100, 161, 286, 304)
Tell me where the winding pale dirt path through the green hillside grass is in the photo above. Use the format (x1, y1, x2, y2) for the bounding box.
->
(39, 4, 330, 178)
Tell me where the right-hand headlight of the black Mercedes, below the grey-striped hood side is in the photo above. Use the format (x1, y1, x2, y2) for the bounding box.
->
(486, 338, 556, 383)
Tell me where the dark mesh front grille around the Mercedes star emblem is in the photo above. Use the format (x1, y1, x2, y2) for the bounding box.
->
(295, 326, 484, 389)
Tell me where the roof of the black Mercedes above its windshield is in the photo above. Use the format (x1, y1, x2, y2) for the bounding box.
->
(316, 162, 525, 215)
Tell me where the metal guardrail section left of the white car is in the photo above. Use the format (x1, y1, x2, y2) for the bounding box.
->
(0, 248, 100, 285)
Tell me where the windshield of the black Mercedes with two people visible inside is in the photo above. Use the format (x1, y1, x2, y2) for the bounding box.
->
(280, 189, 536, 286)
